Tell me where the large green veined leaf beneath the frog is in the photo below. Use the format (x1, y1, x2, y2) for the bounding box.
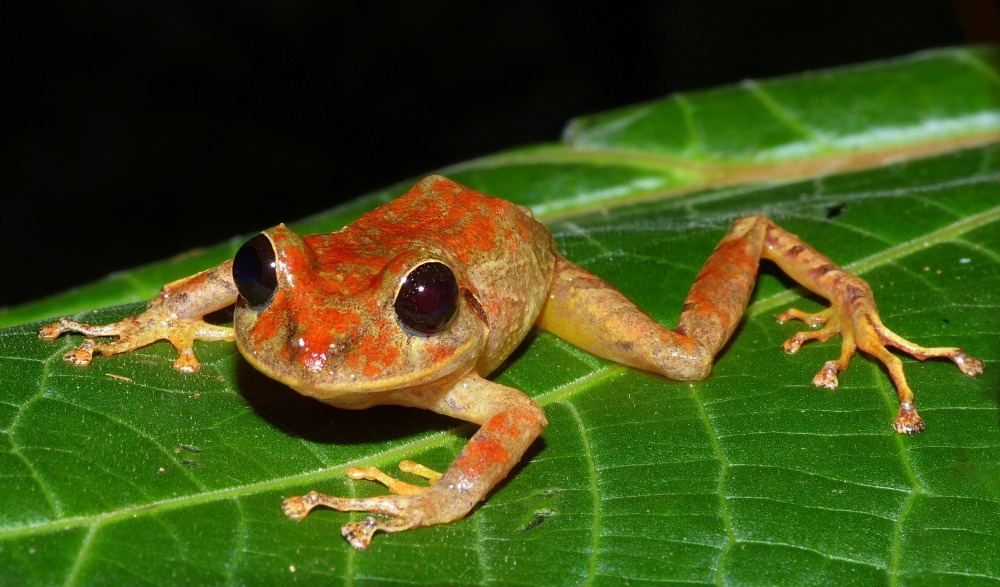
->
(0, 49, 1000, 584)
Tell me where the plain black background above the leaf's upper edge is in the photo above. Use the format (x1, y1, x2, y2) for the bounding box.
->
(0, 0, 1000, 306)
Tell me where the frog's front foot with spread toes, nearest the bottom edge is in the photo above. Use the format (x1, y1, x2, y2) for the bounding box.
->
(281, 460, 441, 550)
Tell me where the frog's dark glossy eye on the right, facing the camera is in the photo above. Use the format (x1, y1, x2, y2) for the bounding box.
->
(393, 261, 458, 334)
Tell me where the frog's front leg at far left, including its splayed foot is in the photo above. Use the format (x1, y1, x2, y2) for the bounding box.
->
(38, 261, 237, 372)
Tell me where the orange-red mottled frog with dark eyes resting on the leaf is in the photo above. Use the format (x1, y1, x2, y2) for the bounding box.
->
(38, 175, 983, 549)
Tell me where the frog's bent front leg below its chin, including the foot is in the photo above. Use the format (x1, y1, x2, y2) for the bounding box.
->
(282, 372, 546, 549)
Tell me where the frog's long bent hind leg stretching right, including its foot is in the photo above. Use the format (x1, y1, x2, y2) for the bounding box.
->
(539, 216, 983, 433)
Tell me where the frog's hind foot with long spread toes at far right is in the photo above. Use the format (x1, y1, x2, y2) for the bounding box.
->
(778, 304, 983, 434)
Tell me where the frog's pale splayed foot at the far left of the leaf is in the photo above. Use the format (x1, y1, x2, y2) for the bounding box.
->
(38, 310, 235, 373)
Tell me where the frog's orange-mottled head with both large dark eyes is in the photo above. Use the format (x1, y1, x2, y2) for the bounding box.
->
(233, 225, 488, 404)
